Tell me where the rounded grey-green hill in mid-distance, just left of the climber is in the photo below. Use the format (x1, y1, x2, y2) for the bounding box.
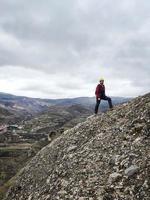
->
(23, 104, 92, 135)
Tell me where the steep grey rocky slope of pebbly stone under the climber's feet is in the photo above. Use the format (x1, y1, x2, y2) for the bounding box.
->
(5, 94, 150, 200)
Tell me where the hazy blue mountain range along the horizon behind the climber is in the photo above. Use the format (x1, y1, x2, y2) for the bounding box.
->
(0, 92, 131, 124)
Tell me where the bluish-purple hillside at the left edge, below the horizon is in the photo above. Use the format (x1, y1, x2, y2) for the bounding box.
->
(0, 92, 49, 124)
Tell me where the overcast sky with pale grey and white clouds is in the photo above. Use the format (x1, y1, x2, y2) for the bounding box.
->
(0, 0, 150, 98)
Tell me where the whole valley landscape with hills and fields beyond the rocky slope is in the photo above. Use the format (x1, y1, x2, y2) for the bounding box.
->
(0, 93, 128, 198)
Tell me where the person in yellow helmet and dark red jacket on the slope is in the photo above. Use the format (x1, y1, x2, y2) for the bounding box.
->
(95, 78, 113, 114)
